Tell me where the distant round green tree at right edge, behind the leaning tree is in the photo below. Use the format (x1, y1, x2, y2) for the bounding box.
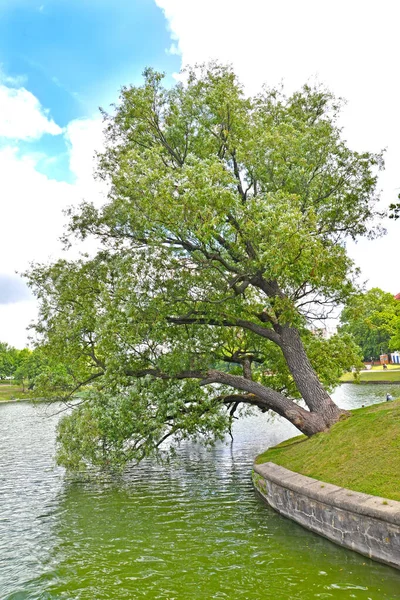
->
(340, 288, 400, 360)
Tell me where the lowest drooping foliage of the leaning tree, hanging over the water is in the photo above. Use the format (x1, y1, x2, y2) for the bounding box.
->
(58, 380, 229, 472)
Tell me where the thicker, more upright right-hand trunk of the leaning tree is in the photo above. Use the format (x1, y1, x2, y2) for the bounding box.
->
(280, 326, 347, 429)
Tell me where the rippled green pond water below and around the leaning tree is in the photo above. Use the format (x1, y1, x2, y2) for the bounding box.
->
(0, 385, 400, 600)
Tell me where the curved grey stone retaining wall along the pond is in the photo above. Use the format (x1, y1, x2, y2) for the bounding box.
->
(253, 462, 400, 569)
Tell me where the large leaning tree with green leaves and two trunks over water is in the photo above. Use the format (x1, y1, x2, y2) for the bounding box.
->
(29, 64, 382, 468)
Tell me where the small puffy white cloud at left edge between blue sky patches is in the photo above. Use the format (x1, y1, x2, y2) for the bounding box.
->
(0, 84, 62, 140)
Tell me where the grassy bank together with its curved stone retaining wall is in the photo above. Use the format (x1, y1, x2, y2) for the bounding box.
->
(252, 398, 400, 569)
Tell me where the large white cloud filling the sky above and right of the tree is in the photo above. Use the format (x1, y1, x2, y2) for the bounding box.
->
(155, 0, 400, 292)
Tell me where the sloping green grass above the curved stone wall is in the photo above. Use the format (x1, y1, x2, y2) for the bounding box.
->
(256, 400, 400, 501)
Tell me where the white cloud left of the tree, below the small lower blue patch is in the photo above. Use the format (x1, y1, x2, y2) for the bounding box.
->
(0, 114, 105, 347)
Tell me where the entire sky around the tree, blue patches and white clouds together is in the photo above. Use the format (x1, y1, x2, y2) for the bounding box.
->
(0, 0, 400, 348)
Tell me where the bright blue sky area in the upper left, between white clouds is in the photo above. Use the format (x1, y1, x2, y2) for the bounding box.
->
(0, 0, 180, 182)
